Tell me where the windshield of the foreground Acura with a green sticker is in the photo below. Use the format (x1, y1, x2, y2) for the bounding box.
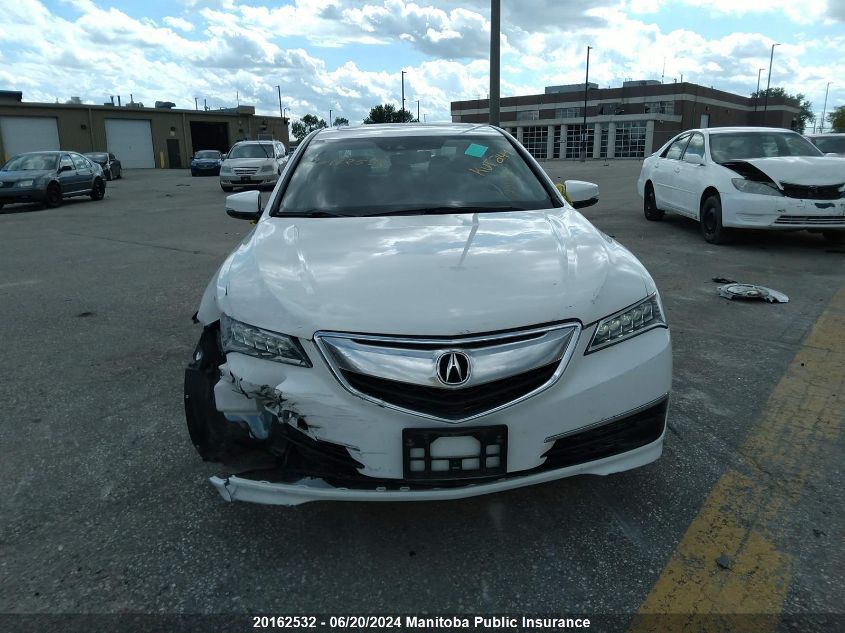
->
(274, 134, 556, 216)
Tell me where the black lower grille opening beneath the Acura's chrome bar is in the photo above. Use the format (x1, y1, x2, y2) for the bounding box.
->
(342, 362, 560, 420)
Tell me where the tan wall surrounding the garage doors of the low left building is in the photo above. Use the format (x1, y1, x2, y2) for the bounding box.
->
(0, 103, 289, 167)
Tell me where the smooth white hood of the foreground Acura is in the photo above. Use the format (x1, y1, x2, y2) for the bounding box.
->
(211, 209, 654, 338)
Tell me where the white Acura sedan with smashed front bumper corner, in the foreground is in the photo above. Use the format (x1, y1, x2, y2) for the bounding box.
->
(185, 124, 672, 505)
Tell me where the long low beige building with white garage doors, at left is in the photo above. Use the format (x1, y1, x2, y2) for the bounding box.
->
(0, 91, 289, 169)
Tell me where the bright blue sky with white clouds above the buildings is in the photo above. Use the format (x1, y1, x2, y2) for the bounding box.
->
(0, 0, 845, 124)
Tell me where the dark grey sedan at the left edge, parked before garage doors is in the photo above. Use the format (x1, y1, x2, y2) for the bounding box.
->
(0, 151, 106, 208)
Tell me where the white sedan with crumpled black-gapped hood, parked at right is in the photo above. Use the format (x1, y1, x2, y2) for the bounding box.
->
(637, 127, 845, 244)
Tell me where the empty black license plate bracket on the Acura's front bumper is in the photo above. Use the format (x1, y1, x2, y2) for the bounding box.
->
(402, 425, 508, 481)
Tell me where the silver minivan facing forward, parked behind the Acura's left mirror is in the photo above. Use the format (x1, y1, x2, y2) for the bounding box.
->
(220, 141, 288, 191)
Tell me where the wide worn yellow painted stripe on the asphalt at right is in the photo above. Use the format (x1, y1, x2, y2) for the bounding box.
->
(630, 287, 845, 633)
